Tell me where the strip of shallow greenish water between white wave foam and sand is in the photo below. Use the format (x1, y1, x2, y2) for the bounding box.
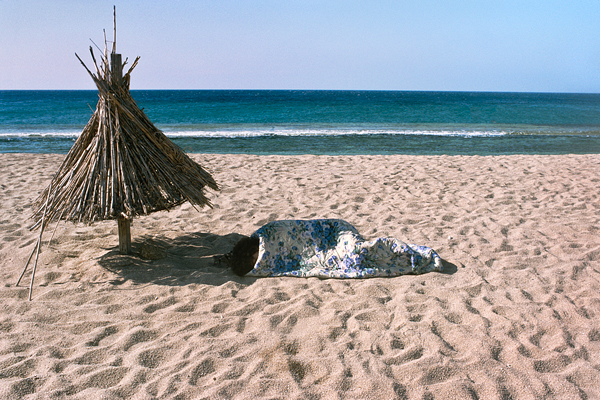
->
(0, 134, 600, 157)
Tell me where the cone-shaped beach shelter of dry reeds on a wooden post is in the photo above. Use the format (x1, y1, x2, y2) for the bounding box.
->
(17, 12, 219, 299)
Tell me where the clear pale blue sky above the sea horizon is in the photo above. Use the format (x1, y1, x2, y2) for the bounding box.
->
(0, 0, 600, 93)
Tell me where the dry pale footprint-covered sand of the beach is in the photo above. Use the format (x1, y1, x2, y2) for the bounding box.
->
(0, 154, 600, 400)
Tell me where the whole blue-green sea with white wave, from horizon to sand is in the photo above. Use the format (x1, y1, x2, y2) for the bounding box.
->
(0, 90, 600, 155)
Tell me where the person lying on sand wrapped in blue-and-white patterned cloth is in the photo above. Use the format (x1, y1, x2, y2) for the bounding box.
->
(225, 219, 443, 278)
